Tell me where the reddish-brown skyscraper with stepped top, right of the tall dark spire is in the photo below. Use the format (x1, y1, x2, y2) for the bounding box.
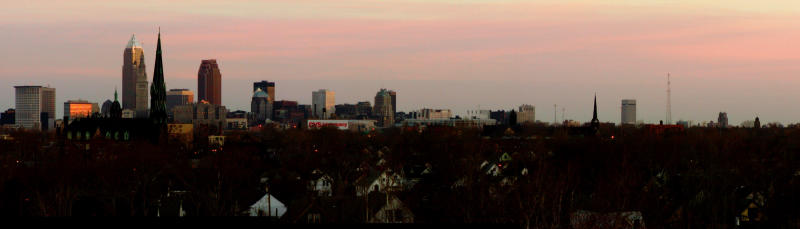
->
(197, 59, 222, 105)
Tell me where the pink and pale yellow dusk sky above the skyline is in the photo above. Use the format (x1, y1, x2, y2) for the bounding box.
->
(0, 0, 800, 125)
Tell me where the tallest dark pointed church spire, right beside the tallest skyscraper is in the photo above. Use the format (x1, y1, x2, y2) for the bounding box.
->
(150, 27, 167, 125)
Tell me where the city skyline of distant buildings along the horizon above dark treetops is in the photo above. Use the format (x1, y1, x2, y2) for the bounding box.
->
(0, 32, 776, 133)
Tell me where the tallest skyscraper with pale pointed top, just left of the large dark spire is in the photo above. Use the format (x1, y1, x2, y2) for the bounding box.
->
(122, 35, 148, 117)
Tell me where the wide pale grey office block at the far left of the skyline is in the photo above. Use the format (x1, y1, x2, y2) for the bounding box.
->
(14, 86, 56, 130)
